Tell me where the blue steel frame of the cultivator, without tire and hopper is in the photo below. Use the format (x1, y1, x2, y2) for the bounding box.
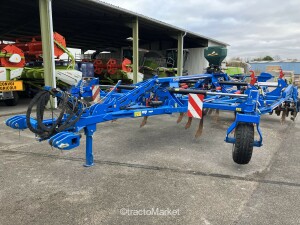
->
(6, 73, 298, 166)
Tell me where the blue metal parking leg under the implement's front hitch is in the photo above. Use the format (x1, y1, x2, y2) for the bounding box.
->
(84, 125, 96, 167)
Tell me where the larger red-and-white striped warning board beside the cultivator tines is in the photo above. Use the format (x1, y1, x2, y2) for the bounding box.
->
(187, 94, 204, 119)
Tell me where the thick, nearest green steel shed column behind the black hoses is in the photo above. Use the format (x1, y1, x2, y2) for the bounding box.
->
(39, 0, 56, 108)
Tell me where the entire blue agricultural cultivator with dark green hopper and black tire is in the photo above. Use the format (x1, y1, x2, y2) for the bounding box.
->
(6, 47, 300, 166)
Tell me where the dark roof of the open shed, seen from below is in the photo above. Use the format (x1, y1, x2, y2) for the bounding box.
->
(0, 0, 228, 50)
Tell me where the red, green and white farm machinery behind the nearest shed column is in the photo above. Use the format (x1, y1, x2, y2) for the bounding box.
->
(0, 32, 82, 106)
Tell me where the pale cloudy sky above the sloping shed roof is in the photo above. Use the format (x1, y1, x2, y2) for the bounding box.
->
(104, 0, 300, 60)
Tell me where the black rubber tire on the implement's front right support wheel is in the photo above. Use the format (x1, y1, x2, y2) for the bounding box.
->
(232, 123, 254, 164)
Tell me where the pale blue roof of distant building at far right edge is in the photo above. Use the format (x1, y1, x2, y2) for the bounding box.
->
(249, 61, 300, 74)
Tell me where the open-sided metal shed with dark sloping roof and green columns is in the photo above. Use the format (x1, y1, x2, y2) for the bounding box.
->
(0, 0, 228, 86)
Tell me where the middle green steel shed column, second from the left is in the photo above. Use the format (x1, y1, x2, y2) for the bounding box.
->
(132, 17, 139, 83)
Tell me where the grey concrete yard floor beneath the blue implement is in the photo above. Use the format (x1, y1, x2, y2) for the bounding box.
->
(0, 100, 300, 225)
